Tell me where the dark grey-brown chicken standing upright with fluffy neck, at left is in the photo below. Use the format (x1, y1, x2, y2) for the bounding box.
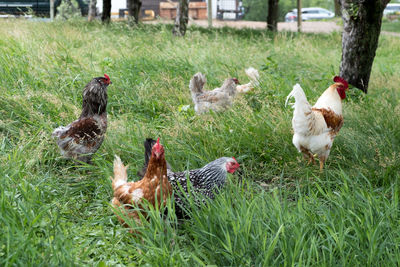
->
(52, 74, 111, 163)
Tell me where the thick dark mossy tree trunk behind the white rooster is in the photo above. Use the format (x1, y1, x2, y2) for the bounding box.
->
(340, 0, 389, 93)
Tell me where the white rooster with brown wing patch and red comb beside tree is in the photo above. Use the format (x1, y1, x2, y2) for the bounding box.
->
(285, 76, 349, 171)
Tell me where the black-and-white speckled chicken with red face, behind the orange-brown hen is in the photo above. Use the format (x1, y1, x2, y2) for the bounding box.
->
(138, 138, 239, 219)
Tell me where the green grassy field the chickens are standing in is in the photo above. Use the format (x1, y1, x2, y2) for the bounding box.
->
(0, 20, 400, 266)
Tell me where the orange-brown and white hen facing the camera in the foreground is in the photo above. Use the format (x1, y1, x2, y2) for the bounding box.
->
(110, 139, 172, 227)
